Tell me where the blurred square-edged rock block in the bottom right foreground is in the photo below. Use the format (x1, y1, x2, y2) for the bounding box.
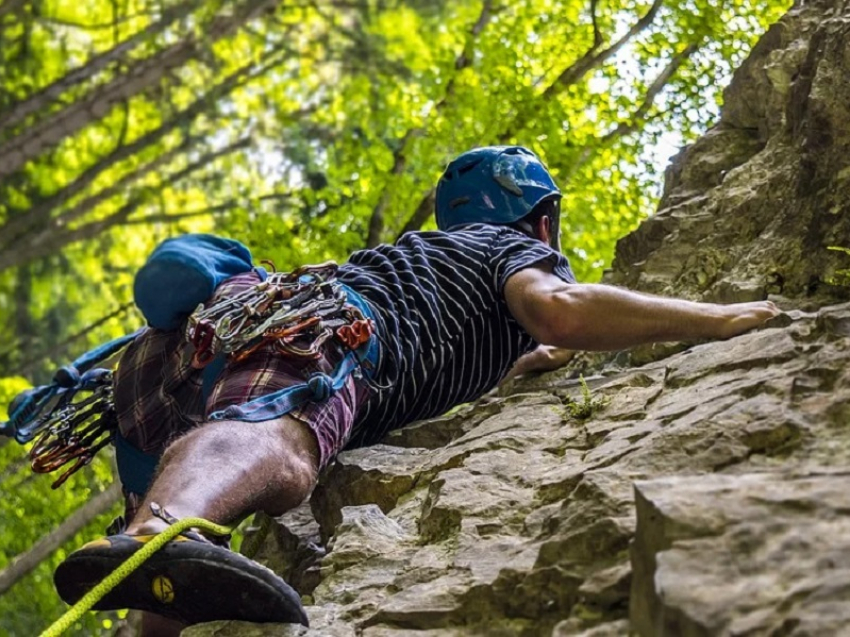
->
(631, 472, 850, 637)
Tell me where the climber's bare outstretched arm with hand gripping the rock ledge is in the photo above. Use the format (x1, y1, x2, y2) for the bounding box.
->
(505, 268, 779, 351)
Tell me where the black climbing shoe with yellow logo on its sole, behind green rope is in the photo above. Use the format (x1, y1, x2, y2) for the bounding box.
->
(53, 534, 308, 626)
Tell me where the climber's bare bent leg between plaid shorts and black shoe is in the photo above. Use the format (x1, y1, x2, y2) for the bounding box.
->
(127, 416, 319, 535)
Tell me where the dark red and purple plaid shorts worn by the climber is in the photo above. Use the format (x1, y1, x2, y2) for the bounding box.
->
(114, 272, 370, 468)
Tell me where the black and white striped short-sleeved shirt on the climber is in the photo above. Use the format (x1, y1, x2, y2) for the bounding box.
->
(338, 224, 575, 447)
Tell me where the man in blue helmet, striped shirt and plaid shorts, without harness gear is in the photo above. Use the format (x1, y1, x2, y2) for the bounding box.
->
(48, 146, 778, 635)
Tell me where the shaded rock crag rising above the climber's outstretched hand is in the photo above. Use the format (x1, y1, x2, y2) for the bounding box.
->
(610, 0, 850, 306)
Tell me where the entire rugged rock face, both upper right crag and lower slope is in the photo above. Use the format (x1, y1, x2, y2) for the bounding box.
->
(184, 0, 850, 637)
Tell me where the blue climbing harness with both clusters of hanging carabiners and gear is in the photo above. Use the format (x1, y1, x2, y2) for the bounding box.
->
(0, 262, 376, 489)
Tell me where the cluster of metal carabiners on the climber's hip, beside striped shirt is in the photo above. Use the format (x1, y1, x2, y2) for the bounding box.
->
(186, 261, 374, 368)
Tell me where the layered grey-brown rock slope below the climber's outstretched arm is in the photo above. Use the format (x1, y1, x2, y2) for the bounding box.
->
(188, 304, 850, 636)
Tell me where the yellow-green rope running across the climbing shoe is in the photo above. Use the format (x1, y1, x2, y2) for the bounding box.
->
(40, 518, 233, 637)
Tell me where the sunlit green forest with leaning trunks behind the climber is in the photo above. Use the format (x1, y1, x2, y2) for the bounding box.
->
(0, 0, 790, 635)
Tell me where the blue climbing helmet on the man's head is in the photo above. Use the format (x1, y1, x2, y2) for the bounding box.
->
(436, 146, 561, 230)
